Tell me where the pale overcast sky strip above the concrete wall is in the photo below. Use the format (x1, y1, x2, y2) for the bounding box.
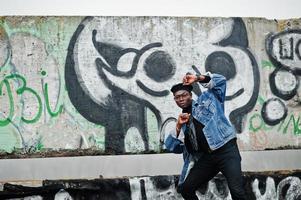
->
(0, 0, 301, 19)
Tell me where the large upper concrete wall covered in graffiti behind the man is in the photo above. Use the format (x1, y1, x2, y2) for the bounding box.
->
(0, 17, 301, 154)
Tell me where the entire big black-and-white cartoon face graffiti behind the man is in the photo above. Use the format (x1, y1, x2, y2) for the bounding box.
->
(65, 17, 260, 152)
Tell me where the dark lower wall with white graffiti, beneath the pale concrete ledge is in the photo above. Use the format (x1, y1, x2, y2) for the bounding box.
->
(0, 171, 301, 200)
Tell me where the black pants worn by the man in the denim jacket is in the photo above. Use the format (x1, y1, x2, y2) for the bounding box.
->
(178, 139, 246, 200)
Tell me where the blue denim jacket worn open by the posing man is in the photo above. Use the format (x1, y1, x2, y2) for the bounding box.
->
(165, 72, 236, 184)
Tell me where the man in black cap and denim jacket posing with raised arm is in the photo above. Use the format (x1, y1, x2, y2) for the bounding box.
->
(165, 72, 246, 200)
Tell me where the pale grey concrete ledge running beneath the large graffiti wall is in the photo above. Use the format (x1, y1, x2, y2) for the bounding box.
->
(0, 150, 301, 182)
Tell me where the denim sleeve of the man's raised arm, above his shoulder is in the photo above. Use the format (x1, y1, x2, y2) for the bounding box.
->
(202, 72, 226, 103)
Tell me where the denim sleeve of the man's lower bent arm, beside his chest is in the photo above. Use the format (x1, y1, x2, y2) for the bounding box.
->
(164, 127, 184, 154)
